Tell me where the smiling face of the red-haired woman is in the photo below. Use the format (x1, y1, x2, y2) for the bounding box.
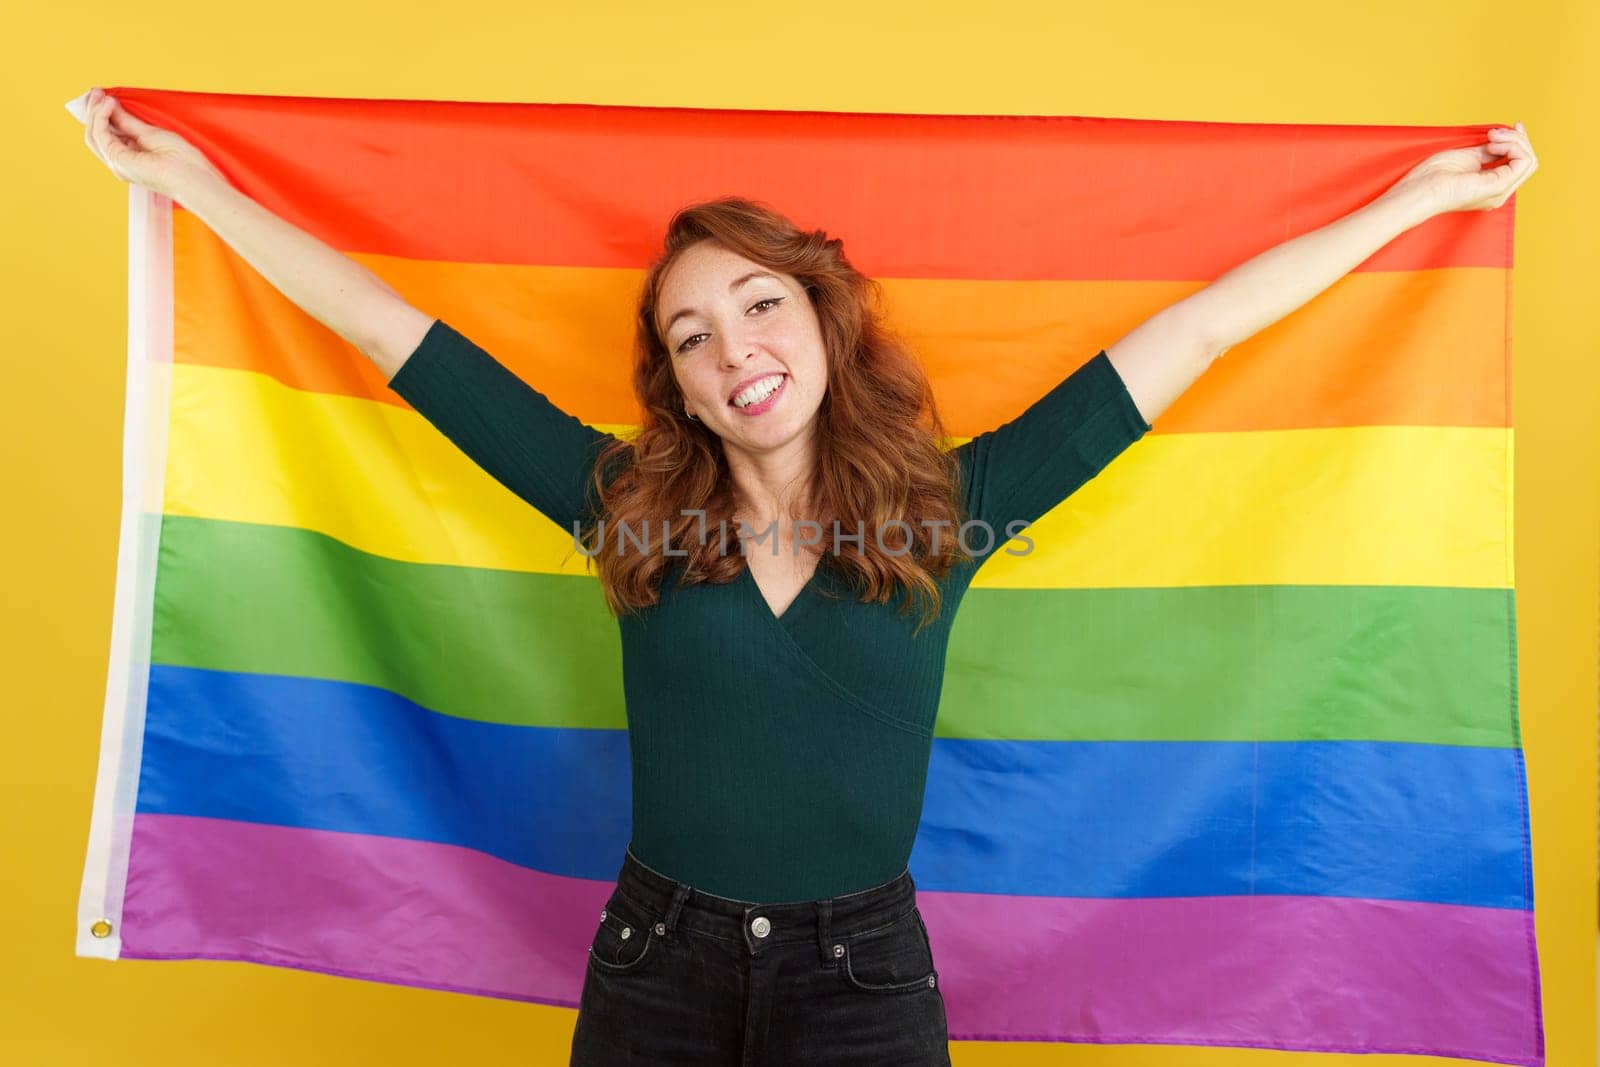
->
(656, 242, 827, 454)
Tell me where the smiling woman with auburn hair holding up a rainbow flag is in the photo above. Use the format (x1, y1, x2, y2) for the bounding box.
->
(86, 85, 1536, 1064)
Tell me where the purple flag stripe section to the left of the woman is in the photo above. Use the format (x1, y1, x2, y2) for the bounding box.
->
(122, 814, 604, 1008)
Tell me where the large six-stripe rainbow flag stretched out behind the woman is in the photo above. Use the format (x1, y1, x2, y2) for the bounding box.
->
(78, 88, 1542, 1064)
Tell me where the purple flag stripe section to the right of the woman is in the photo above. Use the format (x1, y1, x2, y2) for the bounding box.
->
(912, 895, 1542, 1065)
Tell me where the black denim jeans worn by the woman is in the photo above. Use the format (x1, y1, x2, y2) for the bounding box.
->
(571, 849, 950, 1067)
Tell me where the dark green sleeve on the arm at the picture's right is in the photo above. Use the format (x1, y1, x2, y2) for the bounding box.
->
(955, 350, 1150, 561)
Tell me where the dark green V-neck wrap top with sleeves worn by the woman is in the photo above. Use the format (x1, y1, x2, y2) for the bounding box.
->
(390, 322, 1150, 904)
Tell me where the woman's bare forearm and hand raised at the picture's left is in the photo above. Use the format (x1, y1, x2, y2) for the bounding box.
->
(83, 90, 434, 381)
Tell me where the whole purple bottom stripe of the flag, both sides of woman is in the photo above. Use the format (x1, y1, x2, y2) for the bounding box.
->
(122, 814, 1542, 1065)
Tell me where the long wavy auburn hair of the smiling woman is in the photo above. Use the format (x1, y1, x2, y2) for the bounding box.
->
(579, 197, 966, 632)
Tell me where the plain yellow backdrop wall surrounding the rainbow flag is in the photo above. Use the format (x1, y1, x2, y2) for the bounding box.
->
(0, 0, 1600, 1067)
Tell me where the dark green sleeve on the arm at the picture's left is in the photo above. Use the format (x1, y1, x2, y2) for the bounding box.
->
(389, 320, 616, 530)
